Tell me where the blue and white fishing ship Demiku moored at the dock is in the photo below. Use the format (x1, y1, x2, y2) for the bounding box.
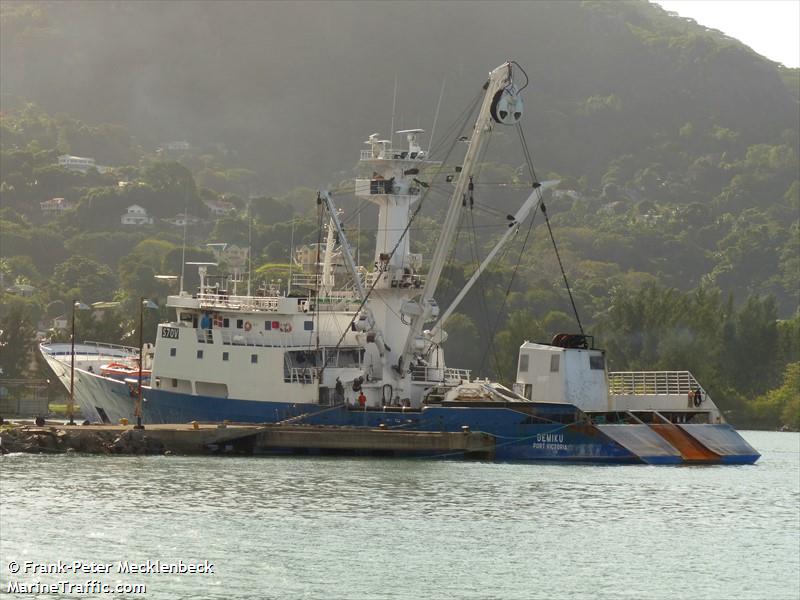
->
(41, 61, 759, 464)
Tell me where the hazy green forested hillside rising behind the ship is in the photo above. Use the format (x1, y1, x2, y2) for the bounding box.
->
(0, 1, 800, 428)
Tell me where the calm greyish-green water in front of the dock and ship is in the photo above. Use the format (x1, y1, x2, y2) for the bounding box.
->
(0, 432, 800, 600)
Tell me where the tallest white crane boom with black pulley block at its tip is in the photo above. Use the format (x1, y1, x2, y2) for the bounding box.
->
(397, 63, 522, 375)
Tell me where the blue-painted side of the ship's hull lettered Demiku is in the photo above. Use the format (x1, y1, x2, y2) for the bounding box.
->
(139, 389, 700, 464)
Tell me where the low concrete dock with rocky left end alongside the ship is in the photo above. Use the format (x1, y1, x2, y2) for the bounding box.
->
(0, 423, 495, 459)
